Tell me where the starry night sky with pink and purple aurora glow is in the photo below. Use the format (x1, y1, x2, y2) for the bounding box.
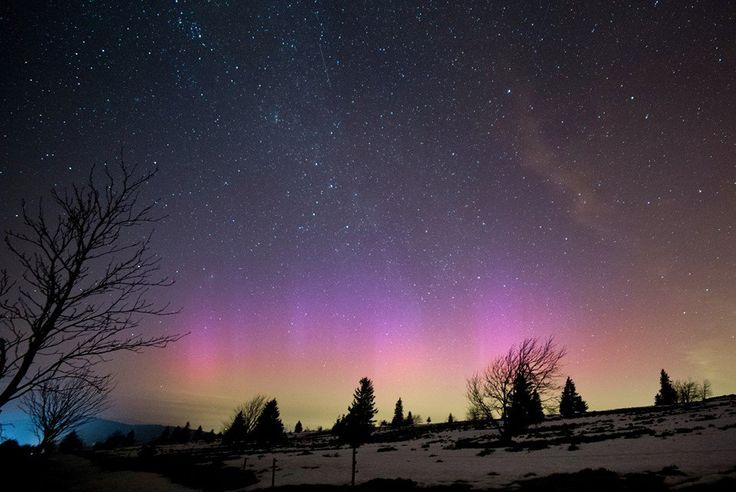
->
(0, 0, 736, 428)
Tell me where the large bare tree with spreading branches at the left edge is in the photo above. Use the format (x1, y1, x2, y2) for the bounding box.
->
(0, 162, 181, 409)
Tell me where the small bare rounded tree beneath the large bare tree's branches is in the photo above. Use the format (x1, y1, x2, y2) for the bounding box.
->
(21, 370, 113, 450)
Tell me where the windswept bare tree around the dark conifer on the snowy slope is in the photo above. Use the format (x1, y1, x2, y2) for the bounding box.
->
(466, 338, 566, 438)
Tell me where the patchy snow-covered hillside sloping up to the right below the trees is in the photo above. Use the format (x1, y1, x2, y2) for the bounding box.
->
(226, 396, 736, 489)
